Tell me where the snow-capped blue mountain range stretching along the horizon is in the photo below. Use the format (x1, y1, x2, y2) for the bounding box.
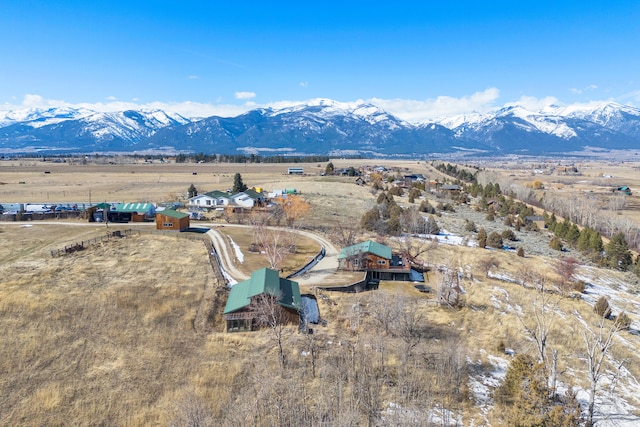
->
(0, 99, 640, 157)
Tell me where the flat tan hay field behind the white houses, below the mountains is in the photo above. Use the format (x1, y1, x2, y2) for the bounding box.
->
(0, 159, 412, 225)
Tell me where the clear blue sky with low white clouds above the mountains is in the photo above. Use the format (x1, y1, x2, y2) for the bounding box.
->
(0, 0, 640, 121)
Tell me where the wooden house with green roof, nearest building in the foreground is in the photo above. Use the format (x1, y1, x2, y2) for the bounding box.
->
(224, 268, 302, 332)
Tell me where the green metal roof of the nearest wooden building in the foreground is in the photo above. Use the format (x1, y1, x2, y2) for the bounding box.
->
(224, 268, 302, 314)
